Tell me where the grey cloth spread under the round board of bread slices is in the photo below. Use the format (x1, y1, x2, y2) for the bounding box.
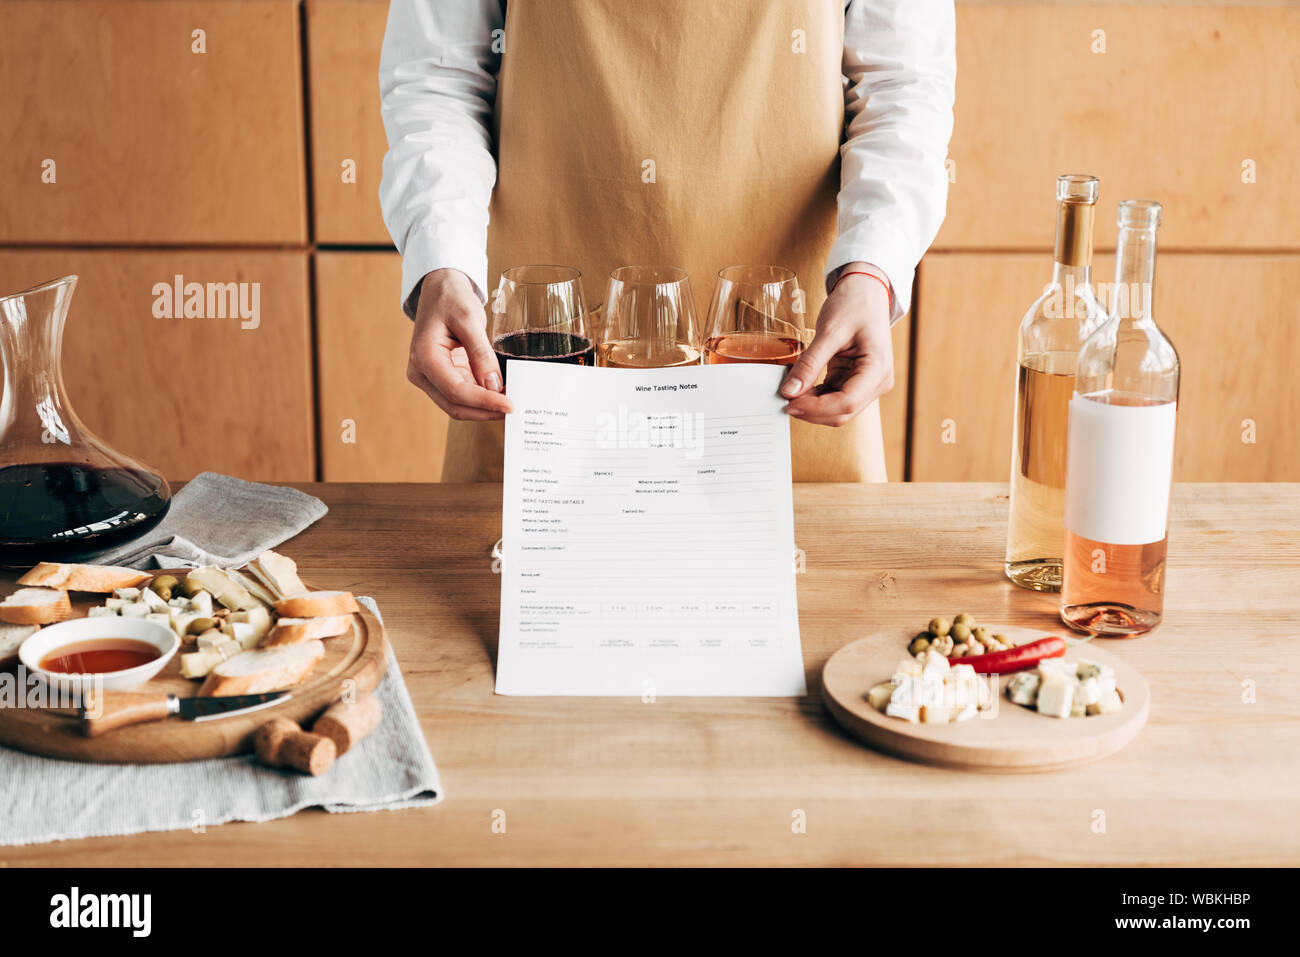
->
(0, 598, 442, 842)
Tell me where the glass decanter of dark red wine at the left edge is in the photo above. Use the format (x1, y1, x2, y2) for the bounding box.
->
(0, 276, 172, 567)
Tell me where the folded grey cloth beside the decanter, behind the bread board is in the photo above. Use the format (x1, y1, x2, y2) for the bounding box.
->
(83, 472, 329, 568)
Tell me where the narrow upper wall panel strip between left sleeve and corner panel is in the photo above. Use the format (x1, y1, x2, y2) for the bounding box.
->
(307, 0, 391, 246)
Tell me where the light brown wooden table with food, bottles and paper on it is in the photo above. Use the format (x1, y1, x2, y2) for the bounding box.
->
(0, 484, 1300, 866)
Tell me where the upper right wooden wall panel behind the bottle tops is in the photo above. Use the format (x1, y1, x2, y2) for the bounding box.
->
(936, 3, 1300, 250)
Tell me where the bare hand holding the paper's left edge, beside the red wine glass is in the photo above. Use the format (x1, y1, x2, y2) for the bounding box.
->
(407, 269, 514, 421)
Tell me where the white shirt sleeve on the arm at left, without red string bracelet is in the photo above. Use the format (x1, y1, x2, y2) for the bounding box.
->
(380, 0, 504, 316)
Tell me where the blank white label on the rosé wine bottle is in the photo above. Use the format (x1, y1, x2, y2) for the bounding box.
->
(1065, 393, 1178, 545)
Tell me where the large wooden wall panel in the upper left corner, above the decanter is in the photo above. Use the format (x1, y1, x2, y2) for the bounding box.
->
(0, 0, 307, 244)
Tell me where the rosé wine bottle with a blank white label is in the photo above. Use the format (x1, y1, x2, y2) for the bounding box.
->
(1061, 199, 1179, 637)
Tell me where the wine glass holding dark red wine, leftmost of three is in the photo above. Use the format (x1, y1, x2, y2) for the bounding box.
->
(488, 265, 595, 386)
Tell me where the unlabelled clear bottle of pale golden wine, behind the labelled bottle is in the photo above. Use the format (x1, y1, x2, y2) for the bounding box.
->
(1004, 176, 1106, 592)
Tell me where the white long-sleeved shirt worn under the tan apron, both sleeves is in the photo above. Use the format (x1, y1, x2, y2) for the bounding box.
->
(380, 0, 957, 320)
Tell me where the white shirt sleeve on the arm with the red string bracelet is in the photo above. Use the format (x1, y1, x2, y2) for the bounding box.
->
(826, 0, 957, 321)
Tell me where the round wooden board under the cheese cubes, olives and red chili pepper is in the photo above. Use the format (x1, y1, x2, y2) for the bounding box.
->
(822, 627, 1151, 771)
